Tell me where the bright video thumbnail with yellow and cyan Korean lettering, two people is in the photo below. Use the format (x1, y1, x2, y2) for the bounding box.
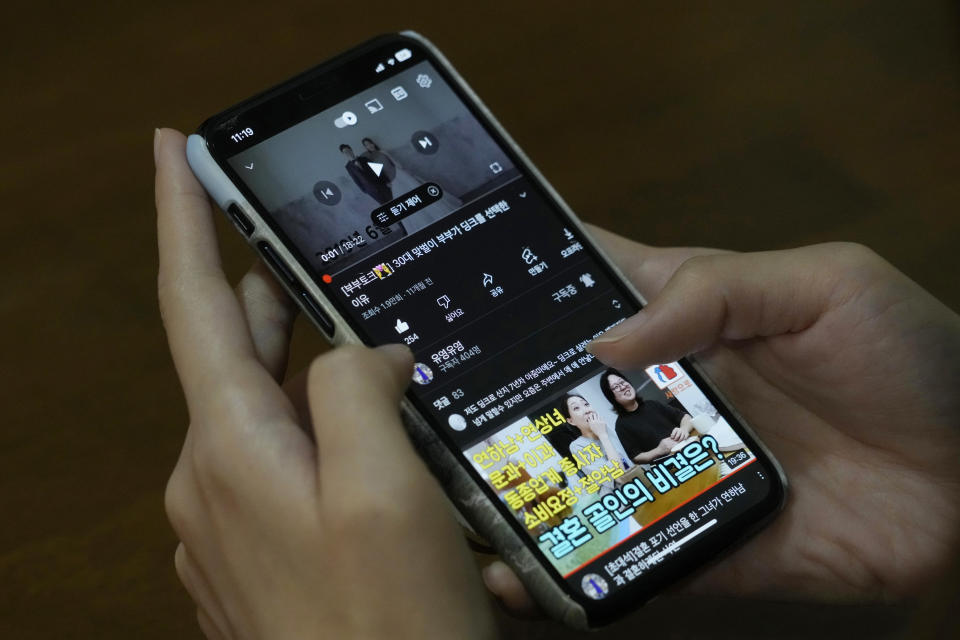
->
(464, 362, 754, 575)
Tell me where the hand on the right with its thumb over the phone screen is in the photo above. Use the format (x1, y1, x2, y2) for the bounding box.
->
(488, 230, 960, 608)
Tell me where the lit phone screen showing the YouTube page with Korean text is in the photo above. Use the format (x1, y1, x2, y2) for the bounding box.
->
(228, 61, 769, 600)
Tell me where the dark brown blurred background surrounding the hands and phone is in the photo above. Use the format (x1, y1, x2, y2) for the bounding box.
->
(0, 0, 960, 639)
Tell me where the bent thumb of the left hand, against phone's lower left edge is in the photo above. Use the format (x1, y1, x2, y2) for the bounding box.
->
(307, 345, 419, 487)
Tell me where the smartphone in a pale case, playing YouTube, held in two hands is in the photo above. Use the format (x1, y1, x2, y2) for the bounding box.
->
(187, 32, 786, 628)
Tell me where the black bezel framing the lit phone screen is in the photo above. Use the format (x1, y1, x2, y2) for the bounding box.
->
(199, 34, 785, 625)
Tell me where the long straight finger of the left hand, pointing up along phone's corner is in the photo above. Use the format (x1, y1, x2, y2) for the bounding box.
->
(155, 129, 256, 406)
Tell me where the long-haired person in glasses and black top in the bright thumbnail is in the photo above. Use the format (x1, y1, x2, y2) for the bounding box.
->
(600, 368, 693, 464)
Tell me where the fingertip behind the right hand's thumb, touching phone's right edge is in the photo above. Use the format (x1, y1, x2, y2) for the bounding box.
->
(587, 225, 727, 300)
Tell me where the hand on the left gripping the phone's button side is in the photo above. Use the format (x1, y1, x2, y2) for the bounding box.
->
(155, 129, 494, 639)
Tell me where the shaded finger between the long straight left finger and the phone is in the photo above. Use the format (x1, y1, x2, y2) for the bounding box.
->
(237, 260, 297, 382)
